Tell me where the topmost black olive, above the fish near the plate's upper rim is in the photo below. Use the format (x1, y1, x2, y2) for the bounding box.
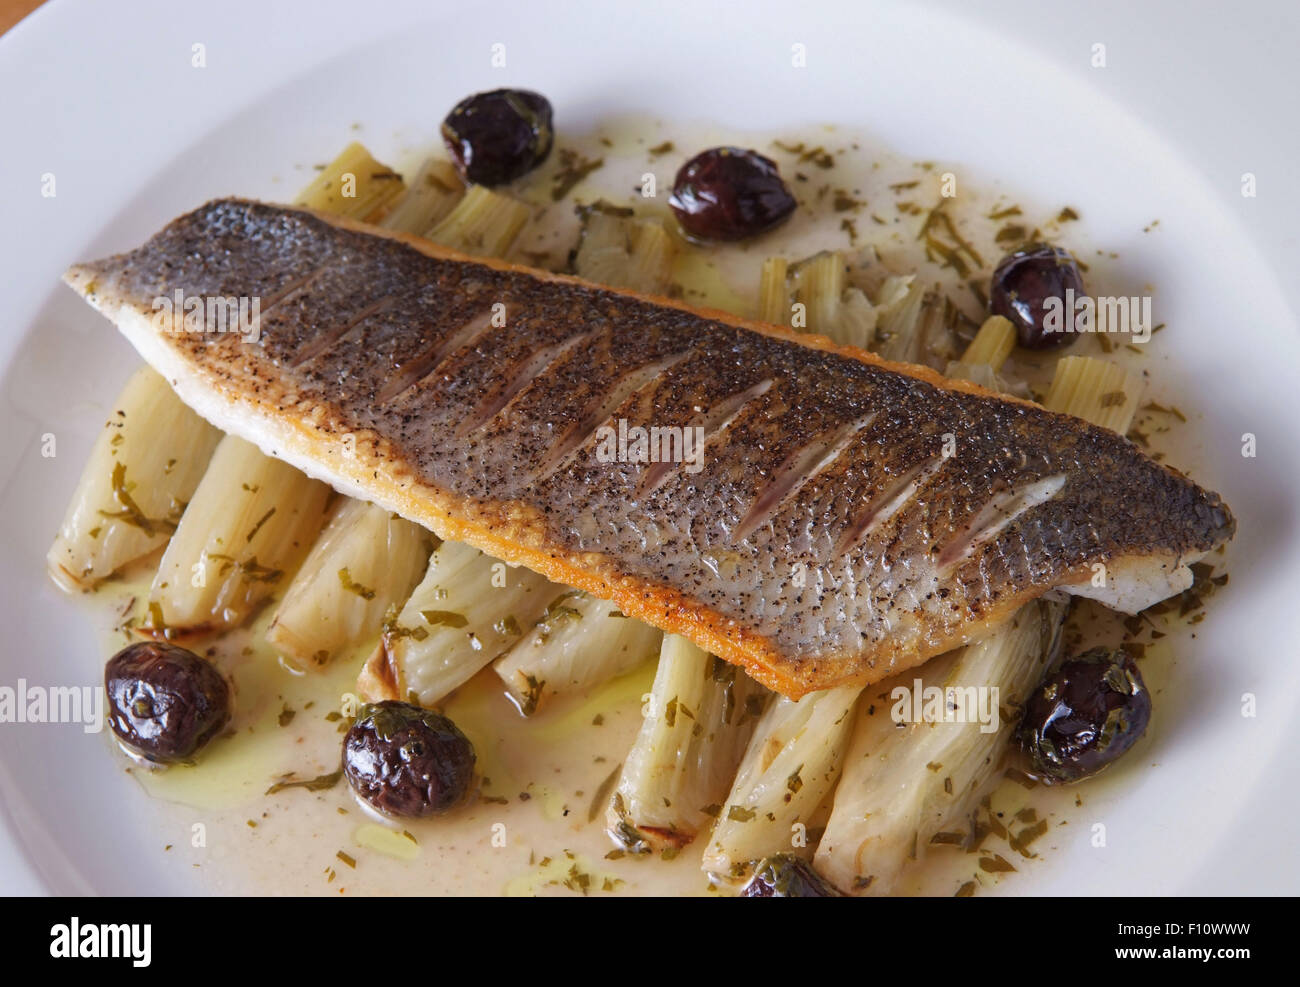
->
(442, 90, 554, 185)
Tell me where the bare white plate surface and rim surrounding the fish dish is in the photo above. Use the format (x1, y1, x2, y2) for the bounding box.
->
(0, 0, 1300, 895)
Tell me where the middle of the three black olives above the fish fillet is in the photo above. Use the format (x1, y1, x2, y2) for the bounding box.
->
(668, 147, 796, 241)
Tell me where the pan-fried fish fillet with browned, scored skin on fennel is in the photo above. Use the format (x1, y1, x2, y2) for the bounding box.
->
(65, 199, 1235, 697)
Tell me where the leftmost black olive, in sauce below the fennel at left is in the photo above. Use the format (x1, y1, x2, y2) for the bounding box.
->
(104, 641, 233, 763)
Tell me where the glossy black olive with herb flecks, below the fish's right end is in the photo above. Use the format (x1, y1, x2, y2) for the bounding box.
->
(1017, 648, 1151, 784)
